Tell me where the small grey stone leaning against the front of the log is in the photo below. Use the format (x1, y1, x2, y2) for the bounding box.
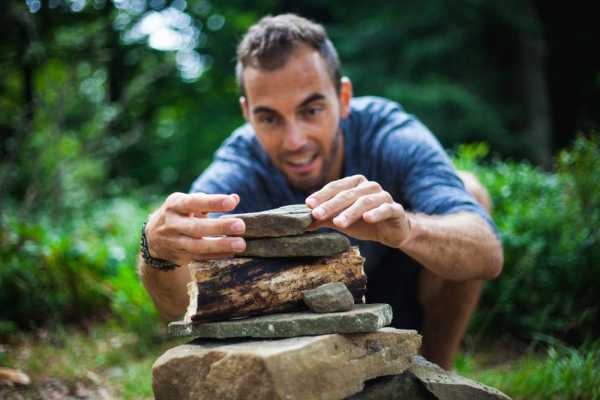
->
(302, 282, 354, 313)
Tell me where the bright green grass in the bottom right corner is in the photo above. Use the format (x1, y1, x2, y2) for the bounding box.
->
(458, 339, 600, 400)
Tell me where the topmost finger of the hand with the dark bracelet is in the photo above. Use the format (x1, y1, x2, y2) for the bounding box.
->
(166, 193, 239, 215)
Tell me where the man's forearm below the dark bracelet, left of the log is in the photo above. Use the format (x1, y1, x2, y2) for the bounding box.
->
(138, 257, 190, 321)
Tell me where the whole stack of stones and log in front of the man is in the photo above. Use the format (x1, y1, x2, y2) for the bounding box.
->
(153, 205, 508, 400)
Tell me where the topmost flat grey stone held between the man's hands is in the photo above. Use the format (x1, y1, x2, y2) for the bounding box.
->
(223, 204, 313, 238)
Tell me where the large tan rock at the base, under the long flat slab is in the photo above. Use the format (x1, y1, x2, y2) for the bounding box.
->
(152, 328, 421, 400)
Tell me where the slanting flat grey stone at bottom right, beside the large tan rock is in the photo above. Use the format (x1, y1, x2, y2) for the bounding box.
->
(408, 356, 510, 400)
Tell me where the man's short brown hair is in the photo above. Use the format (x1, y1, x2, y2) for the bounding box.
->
(235, 14, 341, 95)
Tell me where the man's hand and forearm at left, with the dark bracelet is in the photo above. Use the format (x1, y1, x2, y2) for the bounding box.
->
(138, 193, 246, 320)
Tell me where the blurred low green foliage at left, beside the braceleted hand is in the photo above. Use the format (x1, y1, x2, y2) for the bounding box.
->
(0, 199, 157, 337)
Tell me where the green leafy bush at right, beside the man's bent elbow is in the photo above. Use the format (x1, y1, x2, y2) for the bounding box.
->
(455, 136, 600, 341)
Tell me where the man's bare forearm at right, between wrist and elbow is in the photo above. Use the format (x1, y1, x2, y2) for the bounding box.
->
(400, 213, 503, 281)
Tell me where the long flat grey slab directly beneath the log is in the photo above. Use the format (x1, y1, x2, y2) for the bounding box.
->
(168, 304, 392, 339)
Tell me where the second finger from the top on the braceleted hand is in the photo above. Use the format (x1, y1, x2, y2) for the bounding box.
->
(176, 217, 246, 238)
